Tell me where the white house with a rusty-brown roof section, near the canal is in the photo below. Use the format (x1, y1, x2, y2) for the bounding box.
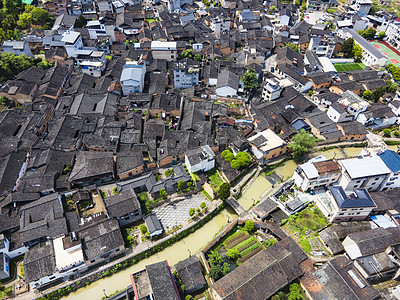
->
(293, 155, 342, 191)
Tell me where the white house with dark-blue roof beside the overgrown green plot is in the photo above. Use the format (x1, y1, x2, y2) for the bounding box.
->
(315, 186, 376, 223)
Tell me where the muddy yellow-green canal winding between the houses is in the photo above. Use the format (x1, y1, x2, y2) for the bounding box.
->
(63, 146, 362, 300)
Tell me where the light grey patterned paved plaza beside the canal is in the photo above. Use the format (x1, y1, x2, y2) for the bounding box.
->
(153, 193, 211, 231)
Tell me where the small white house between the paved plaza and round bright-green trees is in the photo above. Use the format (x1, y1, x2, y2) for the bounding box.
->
(185, 145, 215, 173)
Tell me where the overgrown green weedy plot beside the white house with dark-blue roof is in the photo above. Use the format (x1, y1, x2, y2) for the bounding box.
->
(286, 204, 328, 254)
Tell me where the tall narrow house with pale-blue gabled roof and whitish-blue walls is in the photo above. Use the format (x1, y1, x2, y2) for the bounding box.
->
(120, 61, 146, 96)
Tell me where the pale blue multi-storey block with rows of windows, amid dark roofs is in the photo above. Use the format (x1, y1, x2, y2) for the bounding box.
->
(174, 59, 200, 89)
